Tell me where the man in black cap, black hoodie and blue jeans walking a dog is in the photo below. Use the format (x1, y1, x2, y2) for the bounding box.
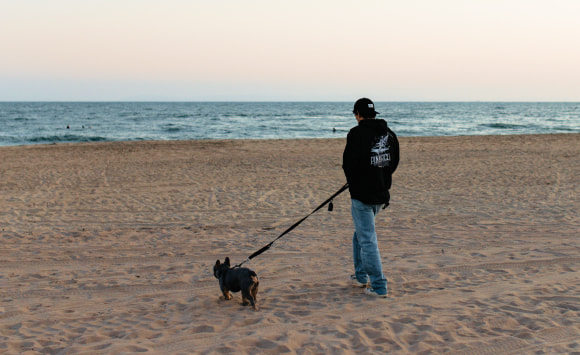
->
(342, 98, 399, 297)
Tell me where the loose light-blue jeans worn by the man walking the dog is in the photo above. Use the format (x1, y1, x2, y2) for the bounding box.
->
(351, 199, 387, 295)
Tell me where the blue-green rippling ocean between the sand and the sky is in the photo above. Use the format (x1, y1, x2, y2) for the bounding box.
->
(0, 102, 580, 146)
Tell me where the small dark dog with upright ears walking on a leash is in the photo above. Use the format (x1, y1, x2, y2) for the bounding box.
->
(213, 257, 260, 311)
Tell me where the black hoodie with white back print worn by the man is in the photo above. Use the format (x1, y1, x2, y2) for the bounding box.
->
(342, 119, 399, 205)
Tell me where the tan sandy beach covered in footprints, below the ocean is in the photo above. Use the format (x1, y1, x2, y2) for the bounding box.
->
(0, 134, 580, 355)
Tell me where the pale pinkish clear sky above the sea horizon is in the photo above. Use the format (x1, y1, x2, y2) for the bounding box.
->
(0, 0, 580, 101)
